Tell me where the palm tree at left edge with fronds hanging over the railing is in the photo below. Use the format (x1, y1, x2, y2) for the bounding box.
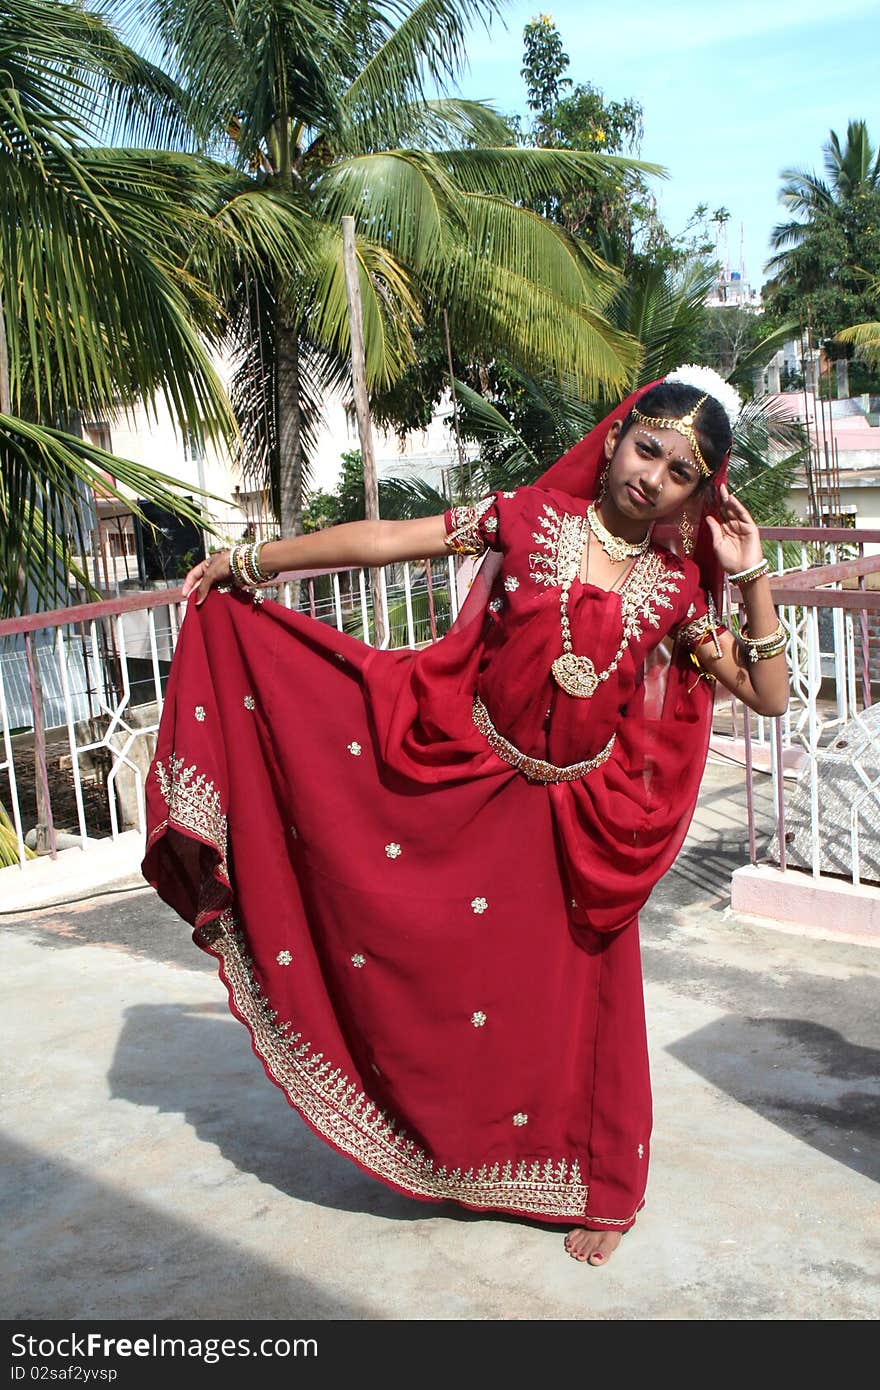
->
(0, 0, 235, 614)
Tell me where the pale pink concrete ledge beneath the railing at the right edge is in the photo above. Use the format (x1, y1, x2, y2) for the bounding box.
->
(730, 865, 880, 945)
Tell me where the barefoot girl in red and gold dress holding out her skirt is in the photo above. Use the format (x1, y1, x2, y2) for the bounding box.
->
(143, 368, 788, 1265)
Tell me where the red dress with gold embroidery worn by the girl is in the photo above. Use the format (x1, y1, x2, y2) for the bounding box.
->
(143, 488, 705, 1230)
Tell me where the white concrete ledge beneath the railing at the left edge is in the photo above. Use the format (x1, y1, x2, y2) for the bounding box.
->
(0, 830, 146, 912)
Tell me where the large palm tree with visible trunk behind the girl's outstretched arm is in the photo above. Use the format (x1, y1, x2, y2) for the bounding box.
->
(123, 0, 651, 532)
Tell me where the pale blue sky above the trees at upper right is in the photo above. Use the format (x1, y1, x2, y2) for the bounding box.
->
(460, 0, 880, 285)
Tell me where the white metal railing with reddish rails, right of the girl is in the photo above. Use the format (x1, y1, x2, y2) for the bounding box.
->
(716, 528, 880, 885)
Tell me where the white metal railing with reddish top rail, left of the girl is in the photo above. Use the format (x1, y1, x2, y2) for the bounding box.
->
(0, 556, 467, 866)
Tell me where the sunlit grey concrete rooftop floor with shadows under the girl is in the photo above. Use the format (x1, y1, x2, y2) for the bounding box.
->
(0, 765, 880, 1321)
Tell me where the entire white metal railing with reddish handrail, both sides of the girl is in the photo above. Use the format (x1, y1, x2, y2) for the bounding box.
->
(0, 528, 880, 884)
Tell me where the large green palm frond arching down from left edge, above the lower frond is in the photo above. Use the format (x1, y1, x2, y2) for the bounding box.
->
(0, 103, 232, 436)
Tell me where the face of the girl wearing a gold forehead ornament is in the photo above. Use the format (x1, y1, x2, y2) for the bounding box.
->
(605, 421, 703, 524)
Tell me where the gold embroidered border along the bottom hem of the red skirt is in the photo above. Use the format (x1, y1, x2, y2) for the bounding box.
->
(196, 910, 588, 1219)
